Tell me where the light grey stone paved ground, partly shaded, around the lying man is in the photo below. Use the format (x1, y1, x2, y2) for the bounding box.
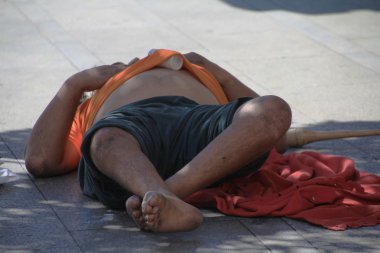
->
(0, 0, 380, 252)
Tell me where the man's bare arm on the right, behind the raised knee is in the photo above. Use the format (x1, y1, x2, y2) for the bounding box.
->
(185, 52, 259, 101)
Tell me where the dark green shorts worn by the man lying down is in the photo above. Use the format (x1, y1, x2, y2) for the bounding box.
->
(78, 96, 266, 209)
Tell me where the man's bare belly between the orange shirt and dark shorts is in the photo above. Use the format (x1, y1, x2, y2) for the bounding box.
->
(95, 68, 218, 121)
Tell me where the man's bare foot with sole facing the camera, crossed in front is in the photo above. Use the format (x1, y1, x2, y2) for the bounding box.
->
(141, 191, 203, 232)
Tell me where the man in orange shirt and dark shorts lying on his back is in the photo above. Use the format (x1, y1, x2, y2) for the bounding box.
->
(25, 50, 291, 232)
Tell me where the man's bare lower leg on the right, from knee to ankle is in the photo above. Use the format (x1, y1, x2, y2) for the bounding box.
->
(127, 96, 291, 230)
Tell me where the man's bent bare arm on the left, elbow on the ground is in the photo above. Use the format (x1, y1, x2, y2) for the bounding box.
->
(25, 65, 125, 176)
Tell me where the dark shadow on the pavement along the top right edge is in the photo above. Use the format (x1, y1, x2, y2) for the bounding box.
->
(222, 0, 380, 14)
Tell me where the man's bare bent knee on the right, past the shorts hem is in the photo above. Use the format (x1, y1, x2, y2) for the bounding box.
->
(235, 95, 292, 137)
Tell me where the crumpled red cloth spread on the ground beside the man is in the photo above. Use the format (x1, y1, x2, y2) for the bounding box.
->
(186, 150, 380, 230)
